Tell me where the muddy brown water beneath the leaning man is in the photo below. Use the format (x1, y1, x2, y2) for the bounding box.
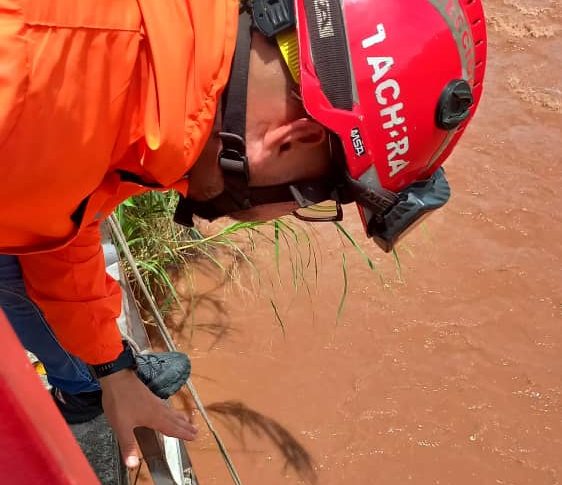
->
(145, 0, 562, 485)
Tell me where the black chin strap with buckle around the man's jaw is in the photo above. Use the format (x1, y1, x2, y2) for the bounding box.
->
(174, 0, 397, 227)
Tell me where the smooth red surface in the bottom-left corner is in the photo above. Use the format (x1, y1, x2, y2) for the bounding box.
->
(0, 310, 99, 485)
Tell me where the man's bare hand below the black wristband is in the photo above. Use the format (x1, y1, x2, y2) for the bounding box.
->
(99, 370, 197, 468)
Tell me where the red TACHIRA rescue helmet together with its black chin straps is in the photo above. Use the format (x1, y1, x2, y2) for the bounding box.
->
(175, 0, 486, 251)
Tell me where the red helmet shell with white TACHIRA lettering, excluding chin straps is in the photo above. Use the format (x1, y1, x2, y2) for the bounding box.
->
(288, 0, 486, 250)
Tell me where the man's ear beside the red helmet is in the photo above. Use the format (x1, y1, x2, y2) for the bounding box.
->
(264, 118, 326, 156)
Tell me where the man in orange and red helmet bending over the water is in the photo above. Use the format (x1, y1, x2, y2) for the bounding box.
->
(0, 0, 486, 466)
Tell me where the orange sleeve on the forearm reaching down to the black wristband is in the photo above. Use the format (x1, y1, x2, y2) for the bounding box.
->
(20, 223, 123, 364)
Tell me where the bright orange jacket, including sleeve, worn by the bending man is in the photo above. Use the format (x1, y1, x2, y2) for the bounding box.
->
(0, 0, 239, 363)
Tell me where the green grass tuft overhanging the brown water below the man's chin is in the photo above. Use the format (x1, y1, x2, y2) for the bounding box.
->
(116, 192, 390, 335)
